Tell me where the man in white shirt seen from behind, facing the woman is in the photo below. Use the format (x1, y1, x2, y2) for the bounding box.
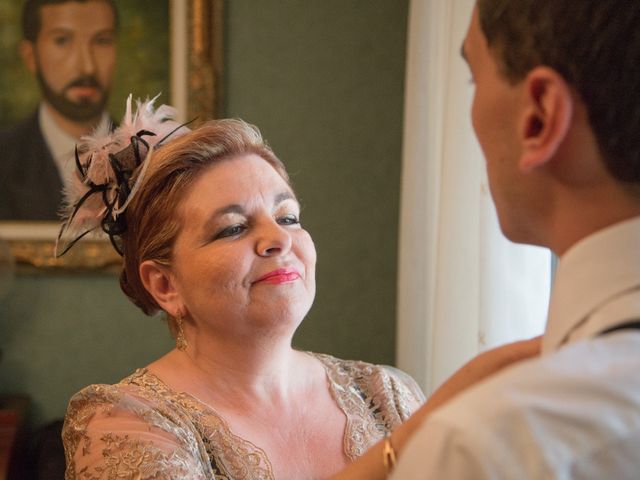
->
(392, 0, 640, 480)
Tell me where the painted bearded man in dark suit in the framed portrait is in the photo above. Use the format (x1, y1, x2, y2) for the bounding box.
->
(0, 0, 118, 220)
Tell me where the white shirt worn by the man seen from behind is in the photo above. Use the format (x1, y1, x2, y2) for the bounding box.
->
(391, 218, 640, 480)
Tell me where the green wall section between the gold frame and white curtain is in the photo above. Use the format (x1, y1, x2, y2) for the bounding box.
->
(226, 0, 407, 363)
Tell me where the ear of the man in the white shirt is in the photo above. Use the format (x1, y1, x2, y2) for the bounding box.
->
(519, 67, 574, 173)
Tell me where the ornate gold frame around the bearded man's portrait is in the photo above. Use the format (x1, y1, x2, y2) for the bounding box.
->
(0, 0, 224, 274)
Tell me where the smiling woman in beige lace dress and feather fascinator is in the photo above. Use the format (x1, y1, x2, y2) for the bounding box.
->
(60, 95, 423, 479)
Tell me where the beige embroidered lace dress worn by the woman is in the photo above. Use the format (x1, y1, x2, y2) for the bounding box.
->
(62, 354, 424, 480)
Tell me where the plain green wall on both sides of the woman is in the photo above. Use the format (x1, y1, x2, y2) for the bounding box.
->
(0, 0, 407, 424)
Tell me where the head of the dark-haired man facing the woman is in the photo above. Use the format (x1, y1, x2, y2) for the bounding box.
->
(463, 0, 640, 251)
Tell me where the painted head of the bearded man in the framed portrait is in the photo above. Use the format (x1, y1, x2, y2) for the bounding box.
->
(21, 0, 118, 122)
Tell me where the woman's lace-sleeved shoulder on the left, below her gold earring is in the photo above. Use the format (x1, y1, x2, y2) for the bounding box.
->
(62, 369, 208, 479)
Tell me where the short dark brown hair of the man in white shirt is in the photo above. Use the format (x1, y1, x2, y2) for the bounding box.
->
(477, 0, 640, 186)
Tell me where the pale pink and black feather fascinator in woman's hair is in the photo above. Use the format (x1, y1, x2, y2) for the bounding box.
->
(55, 95, 189, 257)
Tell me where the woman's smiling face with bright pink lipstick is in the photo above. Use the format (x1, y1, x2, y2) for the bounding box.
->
(171, 154, 316, 338)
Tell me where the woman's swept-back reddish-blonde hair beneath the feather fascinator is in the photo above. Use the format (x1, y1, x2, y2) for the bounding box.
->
(120, 119, 289, 316)
